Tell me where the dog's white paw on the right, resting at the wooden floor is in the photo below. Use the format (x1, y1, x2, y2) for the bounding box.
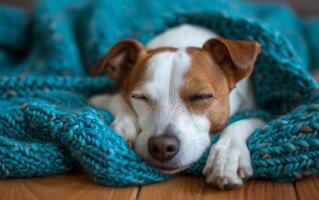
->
(203, 140, 253, 189)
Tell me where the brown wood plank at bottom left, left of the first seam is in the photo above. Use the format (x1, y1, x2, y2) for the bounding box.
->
(0, 173, 139, 200)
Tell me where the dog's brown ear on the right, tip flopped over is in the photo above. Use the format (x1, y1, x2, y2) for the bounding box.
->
(203, 38, 260, 89)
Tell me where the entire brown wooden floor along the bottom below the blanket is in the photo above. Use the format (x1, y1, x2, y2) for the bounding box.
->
(0, 173, 319, 200)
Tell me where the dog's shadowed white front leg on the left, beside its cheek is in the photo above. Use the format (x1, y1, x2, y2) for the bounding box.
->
(89, 93, 139, 147)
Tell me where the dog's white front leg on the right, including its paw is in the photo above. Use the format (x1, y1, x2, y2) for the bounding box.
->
(203, 118, 265, 189)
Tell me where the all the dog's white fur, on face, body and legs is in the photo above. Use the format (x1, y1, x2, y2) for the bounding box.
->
(91, 25, 264, 188)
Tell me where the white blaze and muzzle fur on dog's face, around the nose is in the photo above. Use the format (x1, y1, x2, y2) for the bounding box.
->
(131, 49, 210, 168)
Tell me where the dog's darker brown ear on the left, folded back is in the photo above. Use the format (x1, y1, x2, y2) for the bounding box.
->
(91, 40, 145, 82)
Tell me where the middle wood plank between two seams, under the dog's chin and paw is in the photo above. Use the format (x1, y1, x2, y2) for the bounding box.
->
(138, 177, 297, 200)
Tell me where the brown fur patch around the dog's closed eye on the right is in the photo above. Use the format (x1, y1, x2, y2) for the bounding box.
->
(180, 48, 230, 132)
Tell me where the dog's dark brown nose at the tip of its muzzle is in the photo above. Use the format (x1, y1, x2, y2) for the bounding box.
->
(148, 134, 179, 161)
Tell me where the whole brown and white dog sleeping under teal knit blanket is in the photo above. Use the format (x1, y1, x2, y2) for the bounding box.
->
(91, 24, 264, 188)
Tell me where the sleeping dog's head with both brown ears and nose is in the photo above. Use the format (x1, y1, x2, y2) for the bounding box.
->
(95, 38, 260, 173)
